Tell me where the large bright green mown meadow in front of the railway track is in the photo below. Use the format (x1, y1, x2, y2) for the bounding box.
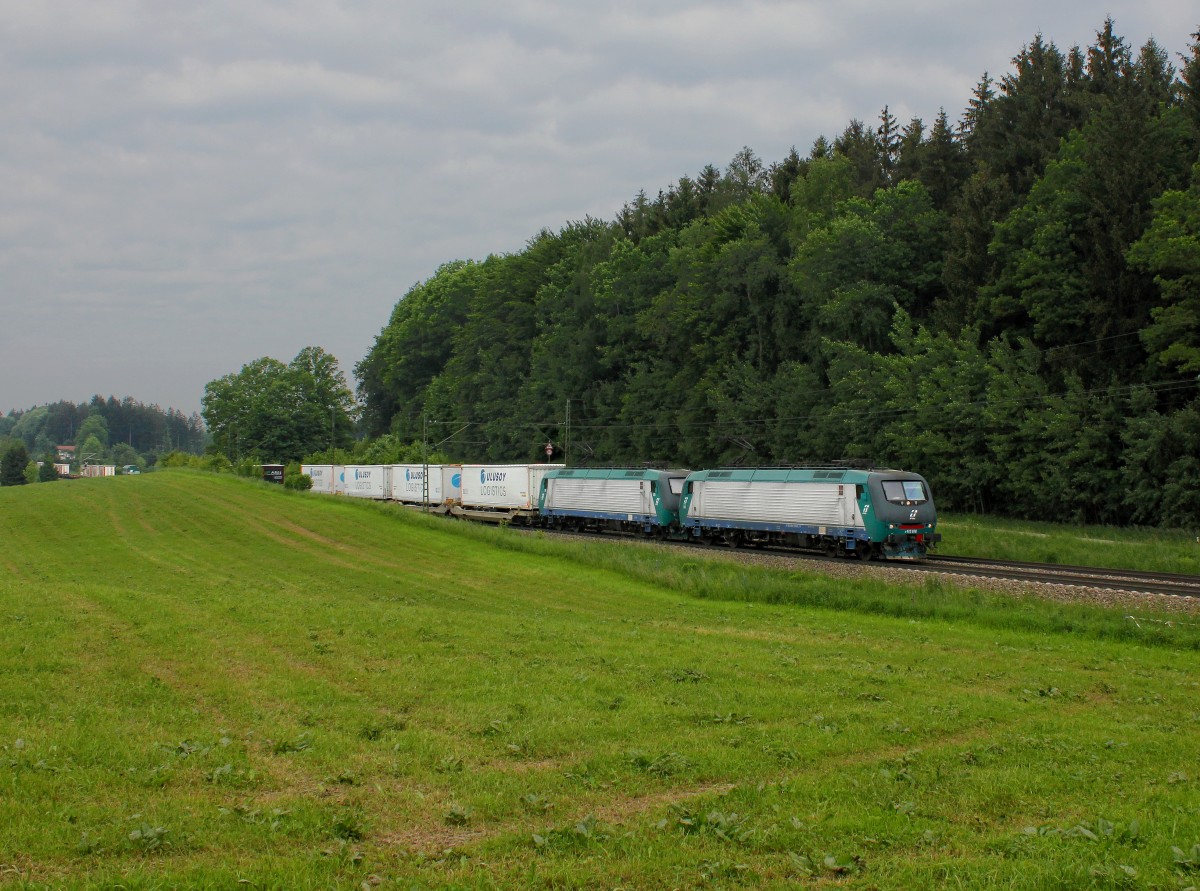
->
(0, 472, 1200, 889)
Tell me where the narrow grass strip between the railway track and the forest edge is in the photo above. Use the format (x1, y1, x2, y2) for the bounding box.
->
(937, 514, 1200, 575)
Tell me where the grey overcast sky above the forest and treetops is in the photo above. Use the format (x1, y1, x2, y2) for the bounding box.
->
(0, 0, 1200, 412)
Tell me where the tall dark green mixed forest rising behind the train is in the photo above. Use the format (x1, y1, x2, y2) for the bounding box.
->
(356, 20, 1200, 527)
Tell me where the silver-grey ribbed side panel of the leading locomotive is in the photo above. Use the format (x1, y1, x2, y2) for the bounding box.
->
(688, 479, 862, 526)
